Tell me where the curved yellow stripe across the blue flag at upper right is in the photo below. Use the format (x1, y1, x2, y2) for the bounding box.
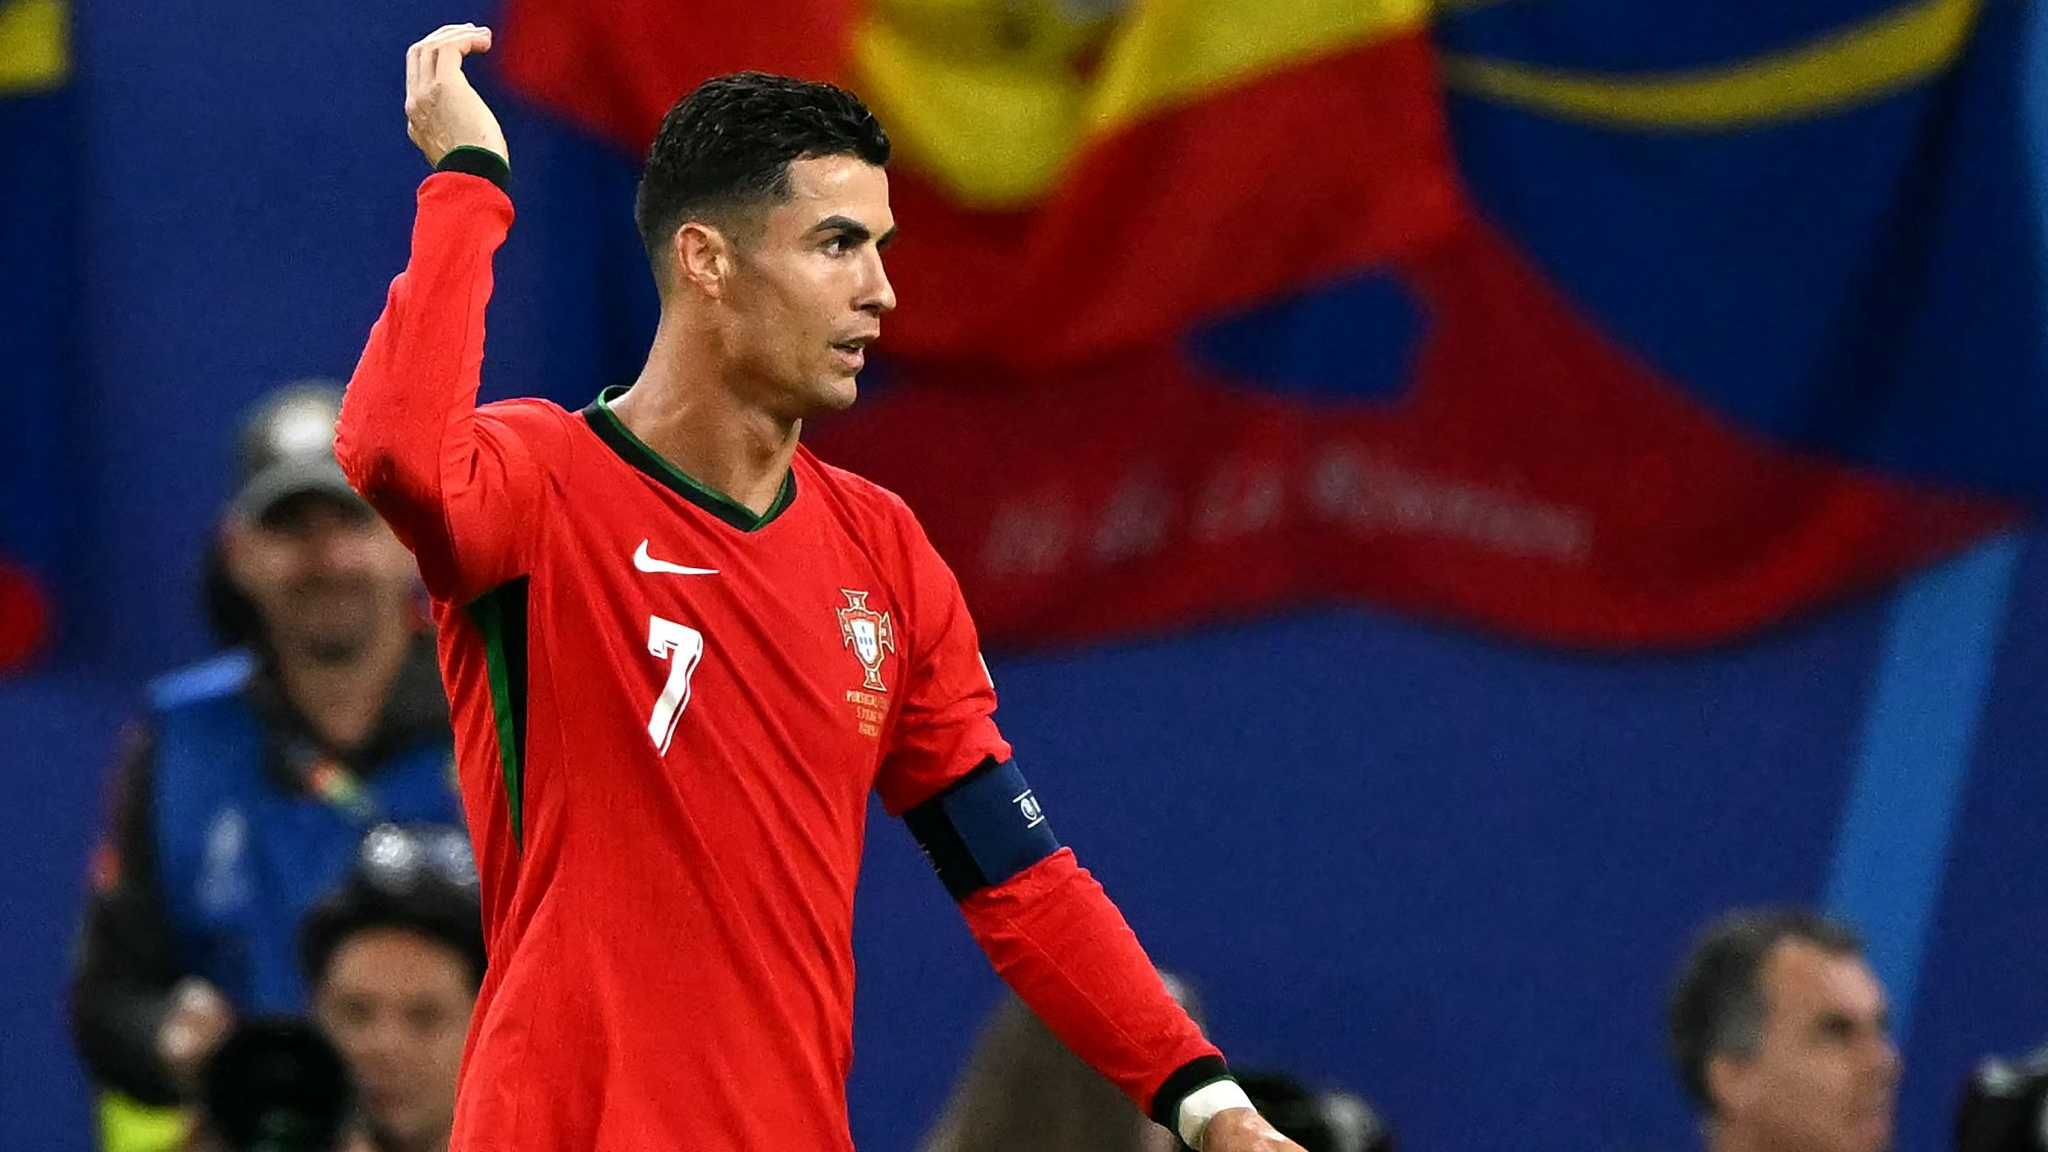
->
(1446, 0, 1982, 131)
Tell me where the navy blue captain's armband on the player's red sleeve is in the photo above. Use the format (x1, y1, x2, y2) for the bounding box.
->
(903, 760, 1059, 900)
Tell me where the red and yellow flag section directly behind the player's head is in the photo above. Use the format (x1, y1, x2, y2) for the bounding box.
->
(504, 0, 1464, 367)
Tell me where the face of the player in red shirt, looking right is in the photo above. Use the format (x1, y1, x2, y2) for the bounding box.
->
(719, 156, 895, 420)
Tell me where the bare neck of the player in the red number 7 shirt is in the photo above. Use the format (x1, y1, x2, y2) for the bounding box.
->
(612, 314, 803, 517)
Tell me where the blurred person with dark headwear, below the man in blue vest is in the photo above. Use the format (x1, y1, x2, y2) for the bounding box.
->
(301, 828, 483, 1152)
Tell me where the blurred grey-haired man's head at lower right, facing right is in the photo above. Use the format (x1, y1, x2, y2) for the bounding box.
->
(1669, 910, 1898, 1152)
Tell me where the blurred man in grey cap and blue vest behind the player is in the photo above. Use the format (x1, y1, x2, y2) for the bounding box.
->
(72, 383, 461, 1146)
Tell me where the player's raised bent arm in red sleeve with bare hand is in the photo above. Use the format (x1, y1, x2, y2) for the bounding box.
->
(334, 25, 563, 603)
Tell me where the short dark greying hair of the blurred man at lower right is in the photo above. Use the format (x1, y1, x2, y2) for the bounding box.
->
(1669, 908, 1864, 1113)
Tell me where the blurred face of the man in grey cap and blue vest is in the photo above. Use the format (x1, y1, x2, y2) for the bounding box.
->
(221, 494, 414, 662)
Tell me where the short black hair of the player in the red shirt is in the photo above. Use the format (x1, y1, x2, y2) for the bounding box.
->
(633, 72, 889, 275)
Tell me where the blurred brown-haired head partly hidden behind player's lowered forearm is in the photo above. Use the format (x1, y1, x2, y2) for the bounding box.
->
(922, 976, 1202, 1152)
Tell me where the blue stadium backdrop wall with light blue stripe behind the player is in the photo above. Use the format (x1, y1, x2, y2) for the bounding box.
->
(0, 0, 2048, 1152)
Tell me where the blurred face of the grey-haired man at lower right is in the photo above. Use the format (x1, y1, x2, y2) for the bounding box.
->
(1708, 941, 1898, 1152)
